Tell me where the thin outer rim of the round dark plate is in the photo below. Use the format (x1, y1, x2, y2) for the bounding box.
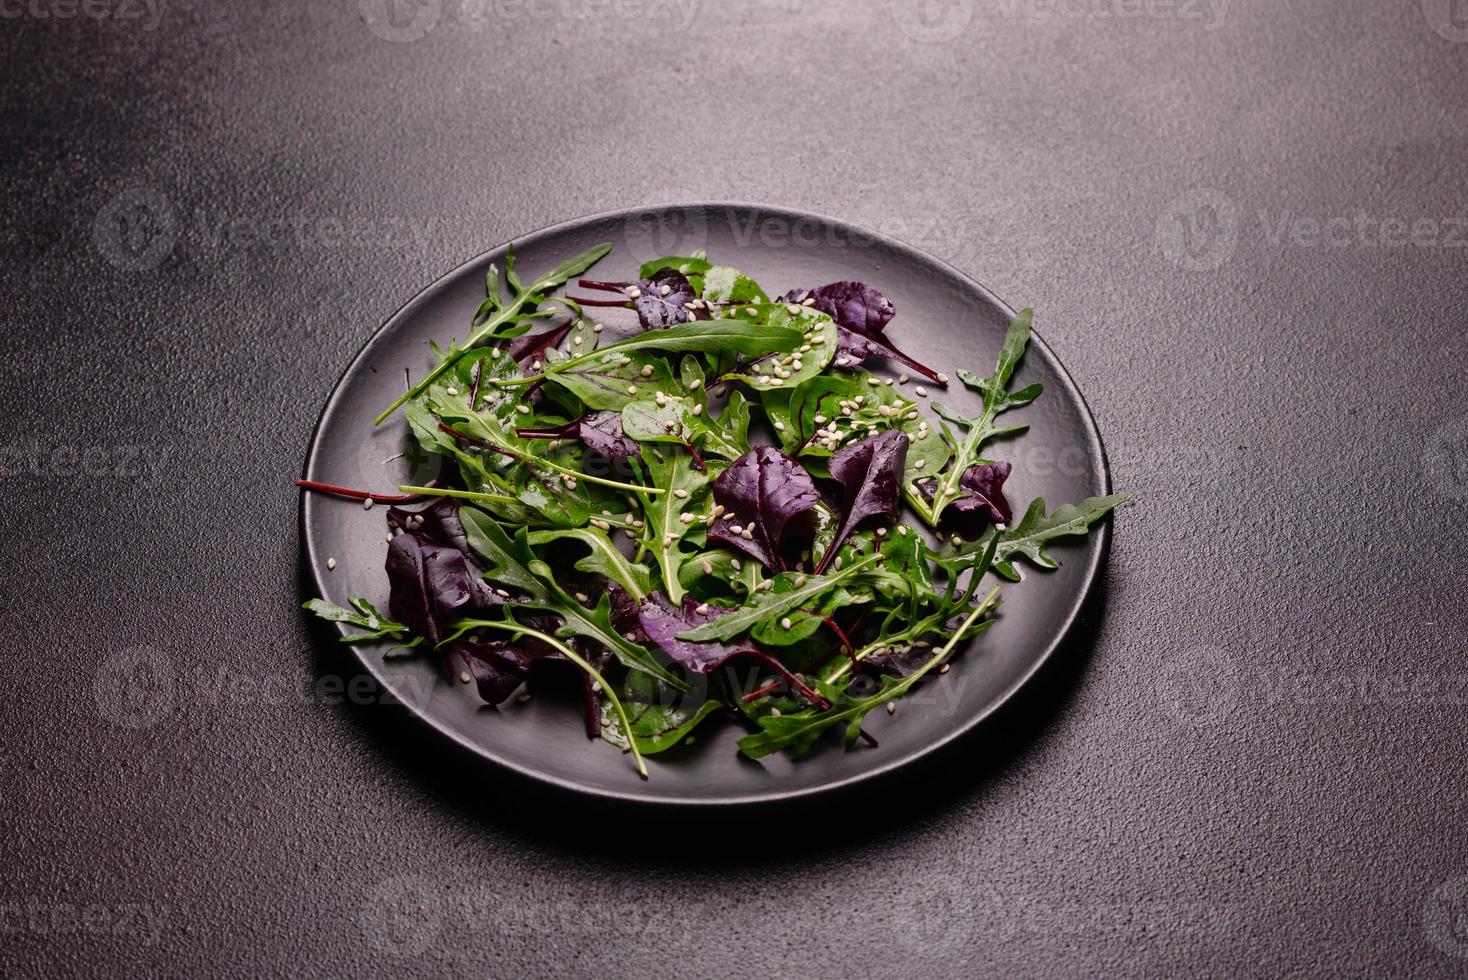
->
(297, 201, 1113, 811)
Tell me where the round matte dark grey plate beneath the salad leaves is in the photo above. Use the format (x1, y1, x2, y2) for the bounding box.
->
(301, 204, 1110, 805)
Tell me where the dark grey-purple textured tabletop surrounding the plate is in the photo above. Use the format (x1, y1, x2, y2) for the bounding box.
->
(0, 0, 1468, 977)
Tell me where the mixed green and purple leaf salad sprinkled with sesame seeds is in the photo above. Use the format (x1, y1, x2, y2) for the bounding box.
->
(302, 245, 1129, 778)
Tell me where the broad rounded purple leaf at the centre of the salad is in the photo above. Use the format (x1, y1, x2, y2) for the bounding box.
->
(709, 446, 821, 571)
